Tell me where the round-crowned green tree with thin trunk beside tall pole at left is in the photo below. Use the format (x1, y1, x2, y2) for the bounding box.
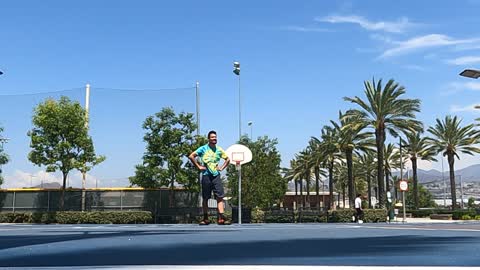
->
(28, 97, 105, 209)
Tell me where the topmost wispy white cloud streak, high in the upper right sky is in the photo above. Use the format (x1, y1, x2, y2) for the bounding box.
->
(315, 15, 415, 33)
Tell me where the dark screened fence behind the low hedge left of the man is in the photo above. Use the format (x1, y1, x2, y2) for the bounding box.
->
(0, 188, 207, 223)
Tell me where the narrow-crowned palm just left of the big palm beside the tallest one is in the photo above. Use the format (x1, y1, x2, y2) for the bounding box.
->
(312, 126, 340, 209)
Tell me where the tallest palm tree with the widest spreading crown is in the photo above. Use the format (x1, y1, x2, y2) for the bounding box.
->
(344, 79, 422, 207)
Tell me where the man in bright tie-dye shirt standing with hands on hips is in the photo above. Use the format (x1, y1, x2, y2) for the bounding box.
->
(188, 130, 230, 225)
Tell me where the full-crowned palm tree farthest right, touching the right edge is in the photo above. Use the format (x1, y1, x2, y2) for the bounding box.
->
(427, 116, 480, 209)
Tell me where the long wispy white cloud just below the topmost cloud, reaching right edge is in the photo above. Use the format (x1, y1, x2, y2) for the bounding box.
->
(380, 34, 480, 58)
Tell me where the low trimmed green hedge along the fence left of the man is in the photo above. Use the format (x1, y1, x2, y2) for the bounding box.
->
(0, 211, 152, 224)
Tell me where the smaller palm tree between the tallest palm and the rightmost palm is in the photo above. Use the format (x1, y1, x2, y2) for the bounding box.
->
(405, 132, 437, 209)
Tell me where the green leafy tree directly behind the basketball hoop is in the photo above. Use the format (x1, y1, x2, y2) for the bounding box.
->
(227, 136, 288, 208)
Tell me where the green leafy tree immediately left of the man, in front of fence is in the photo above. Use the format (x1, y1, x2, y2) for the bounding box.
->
(129, 107, 200, 205)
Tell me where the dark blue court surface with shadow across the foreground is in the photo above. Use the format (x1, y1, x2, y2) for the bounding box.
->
(0, 220, 480, 269)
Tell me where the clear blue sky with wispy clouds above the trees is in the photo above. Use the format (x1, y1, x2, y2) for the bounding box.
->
(0, 0, 480, 187)
